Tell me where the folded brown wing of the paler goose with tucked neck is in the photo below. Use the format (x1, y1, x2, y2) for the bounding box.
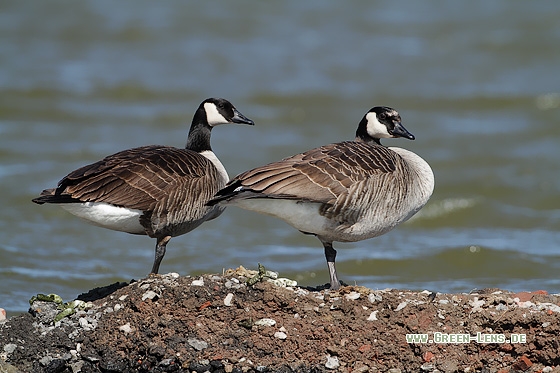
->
(231, 141, 399, 204)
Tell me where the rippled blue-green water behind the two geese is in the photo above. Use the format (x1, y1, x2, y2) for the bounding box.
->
(0, 0, 560, 314)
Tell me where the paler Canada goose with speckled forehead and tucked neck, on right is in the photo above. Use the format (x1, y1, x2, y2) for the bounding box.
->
(209, 106, 434, 289)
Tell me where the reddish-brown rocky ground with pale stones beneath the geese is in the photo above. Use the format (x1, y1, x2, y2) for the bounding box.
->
(0, 268, 560, 373)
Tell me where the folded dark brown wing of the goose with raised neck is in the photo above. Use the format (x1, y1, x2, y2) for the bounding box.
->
(39, 146, 218, 211)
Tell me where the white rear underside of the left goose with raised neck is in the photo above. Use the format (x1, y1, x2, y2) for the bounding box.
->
(60, 202, 145, 234)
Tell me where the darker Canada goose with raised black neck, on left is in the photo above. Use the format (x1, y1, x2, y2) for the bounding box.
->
(33, 98, 254, 273)
